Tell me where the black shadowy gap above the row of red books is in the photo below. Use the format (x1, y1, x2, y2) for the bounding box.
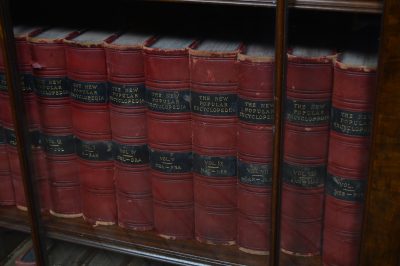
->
(10, 0, 381, 51)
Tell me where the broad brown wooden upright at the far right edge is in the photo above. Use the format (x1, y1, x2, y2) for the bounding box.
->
(360, 0, 400, 265)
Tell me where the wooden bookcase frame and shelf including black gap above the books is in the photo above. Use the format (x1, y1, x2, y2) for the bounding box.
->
(0, 0, 400, 265)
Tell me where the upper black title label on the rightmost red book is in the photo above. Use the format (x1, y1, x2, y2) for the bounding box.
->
(331, 107, 372, 136)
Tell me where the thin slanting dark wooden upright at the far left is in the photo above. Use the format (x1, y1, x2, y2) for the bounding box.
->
(0, 0, 47, 266)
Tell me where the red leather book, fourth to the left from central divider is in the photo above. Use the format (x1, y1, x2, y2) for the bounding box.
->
(104, 33, 153, 231)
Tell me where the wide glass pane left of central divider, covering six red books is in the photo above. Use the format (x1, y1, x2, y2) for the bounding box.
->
(8, 1, 274, 265)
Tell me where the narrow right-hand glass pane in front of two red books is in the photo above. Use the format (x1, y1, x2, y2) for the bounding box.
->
(281, 9, 379, 266)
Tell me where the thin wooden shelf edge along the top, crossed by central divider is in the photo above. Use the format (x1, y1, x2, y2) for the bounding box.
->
(146, 0, 383, 13)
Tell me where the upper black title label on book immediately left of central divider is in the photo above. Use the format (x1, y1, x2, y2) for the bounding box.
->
(238, 98, 274, 124)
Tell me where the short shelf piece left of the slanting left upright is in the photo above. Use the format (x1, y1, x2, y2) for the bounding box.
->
(0, 206, 31, 233)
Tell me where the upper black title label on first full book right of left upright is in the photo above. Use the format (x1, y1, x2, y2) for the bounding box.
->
(35, 77, 69, 98)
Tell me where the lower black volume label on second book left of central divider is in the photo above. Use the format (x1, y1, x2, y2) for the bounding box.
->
(193, 153, 236, 177)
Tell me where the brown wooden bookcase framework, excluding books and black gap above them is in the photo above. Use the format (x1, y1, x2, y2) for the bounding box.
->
(0, 0, 400, 265)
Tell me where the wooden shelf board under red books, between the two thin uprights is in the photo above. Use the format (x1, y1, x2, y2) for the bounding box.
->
(43, 216, 269, 266)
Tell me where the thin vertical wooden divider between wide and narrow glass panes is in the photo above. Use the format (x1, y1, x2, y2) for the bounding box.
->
(270, 0, 288, 266)
